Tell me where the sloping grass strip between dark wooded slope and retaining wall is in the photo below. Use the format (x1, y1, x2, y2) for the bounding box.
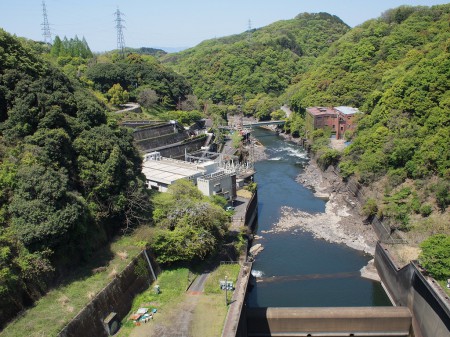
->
(0, 227, 153, 337)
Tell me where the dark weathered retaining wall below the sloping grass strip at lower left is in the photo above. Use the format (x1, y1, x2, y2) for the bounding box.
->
(58, 252, 157, 337)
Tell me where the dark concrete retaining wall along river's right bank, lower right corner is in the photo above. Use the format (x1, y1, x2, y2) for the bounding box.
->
(375, 243, 450, 337)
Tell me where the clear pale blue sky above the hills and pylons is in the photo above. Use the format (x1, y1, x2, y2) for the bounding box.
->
(0, 0, 448, 51)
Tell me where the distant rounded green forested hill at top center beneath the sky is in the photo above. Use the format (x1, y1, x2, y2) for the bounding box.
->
(162, 13, 349, 104)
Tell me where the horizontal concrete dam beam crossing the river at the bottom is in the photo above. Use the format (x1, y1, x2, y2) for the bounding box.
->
(247, 307, 411, 337)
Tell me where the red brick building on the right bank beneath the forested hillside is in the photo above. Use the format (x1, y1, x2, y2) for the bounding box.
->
(305, 106, 360, 139)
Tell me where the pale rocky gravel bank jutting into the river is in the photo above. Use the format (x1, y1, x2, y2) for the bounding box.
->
(262, 130, 377, 255)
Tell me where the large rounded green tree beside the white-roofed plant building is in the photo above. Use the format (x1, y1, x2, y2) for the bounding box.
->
(151, 180, 228, 264)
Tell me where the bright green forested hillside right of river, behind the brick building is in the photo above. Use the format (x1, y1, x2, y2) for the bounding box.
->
(286, 5, 450, 233)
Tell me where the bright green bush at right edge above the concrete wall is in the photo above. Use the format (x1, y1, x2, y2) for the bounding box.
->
(419, 234, 450, 280)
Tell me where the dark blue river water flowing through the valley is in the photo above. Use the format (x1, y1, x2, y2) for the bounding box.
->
(248, 129, 391, 307)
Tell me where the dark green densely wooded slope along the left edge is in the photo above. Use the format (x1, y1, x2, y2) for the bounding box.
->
(0, 30, 151, 327)
